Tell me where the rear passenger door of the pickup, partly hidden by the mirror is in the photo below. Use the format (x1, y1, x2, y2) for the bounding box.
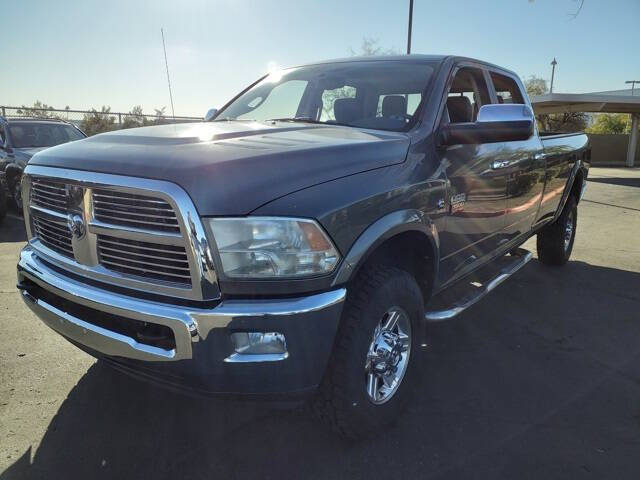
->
(489, 71, 545, 243)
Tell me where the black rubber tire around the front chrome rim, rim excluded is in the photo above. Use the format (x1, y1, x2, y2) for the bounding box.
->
(313, 265, 424, 438)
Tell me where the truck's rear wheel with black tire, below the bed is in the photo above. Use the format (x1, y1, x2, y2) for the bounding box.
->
(537, 196, 578, 266)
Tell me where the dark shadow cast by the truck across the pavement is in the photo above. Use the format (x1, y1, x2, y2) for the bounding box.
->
(0, 261, 640, 480)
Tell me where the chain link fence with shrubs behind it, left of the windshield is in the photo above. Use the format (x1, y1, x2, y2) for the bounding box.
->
(0, 106, 202, 136)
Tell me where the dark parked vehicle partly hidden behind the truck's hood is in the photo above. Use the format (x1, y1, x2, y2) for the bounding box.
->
(0, 117, 86, 212)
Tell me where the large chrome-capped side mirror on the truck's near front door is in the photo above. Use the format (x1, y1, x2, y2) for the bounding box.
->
(440, 104, 535, 145)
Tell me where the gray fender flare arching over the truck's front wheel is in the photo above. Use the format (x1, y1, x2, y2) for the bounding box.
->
(331, 209, 440, 286)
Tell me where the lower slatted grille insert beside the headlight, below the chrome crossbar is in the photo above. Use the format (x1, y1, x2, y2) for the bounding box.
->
(98, 235, 191, 285)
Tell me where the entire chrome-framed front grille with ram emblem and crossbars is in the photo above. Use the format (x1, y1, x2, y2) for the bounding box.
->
(23, 165, 220, 300)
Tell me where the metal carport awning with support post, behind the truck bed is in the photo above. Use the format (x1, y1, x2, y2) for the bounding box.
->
(531, 91, 640, 167)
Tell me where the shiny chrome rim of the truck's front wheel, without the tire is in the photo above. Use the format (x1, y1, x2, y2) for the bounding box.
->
(365, 307, 411, 404)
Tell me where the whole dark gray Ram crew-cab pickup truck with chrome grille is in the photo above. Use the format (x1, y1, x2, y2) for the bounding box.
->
(18, 55, 590, 436)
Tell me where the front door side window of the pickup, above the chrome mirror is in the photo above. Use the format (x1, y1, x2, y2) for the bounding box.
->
(445, 67, 491, 123)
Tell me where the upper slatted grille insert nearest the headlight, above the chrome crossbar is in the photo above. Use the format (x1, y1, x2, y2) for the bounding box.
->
(93, 189, 180, 232)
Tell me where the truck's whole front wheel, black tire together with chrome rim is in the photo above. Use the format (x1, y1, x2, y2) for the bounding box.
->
(314, 265, 424, 438)
